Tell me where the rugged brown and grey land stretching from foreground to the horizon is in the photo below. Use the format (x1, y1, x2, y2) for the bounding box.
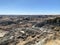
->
(0, 15, 60, 45)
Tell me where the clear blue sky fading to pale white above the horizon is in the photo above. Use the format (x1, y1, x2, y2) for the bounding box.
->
(0, 0, 60, 14)
